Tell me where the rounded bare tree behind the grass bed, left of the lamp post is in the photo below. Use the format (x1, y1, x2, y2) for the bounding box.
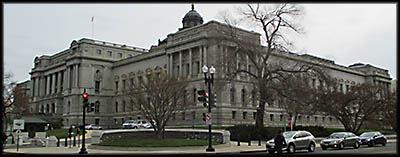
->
(127, 73, 192, 138)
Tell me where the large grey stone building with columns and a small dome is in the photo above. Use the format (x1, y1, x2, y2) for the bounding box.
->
(30, 6, 391, 128)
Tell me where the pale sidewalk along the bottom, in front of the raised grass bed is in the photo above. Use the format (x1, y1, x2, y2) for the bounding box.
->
(4, 139, 397, 154)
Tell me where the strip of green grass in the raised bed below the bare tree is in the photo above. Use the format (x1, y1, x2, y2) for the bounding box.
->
(99, 139, 219, 147)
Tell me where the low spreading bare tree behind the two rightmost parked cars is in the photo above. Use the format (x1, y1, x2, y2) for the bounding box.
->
(316, 79, 385, 132)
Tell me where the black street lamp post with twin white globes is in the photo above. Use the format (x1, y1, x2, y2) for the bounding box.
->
(202, 65, 215, 152)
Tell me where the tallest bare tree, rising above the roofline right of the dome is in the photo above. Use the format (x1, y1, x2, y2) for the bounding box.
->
(219, 3, 313, 126)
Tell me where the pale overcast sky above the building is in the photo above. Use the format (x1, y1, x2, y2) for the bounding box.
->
(3, 3, 397, 82)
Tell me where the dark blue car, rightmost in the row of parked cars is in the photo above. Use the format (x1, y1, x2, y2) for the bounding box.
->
(360, 132, 387, 147)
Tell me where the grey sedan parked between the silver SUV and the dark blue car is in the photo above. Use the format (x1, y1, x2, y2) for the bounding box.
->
(320, 132, 360, 150)
